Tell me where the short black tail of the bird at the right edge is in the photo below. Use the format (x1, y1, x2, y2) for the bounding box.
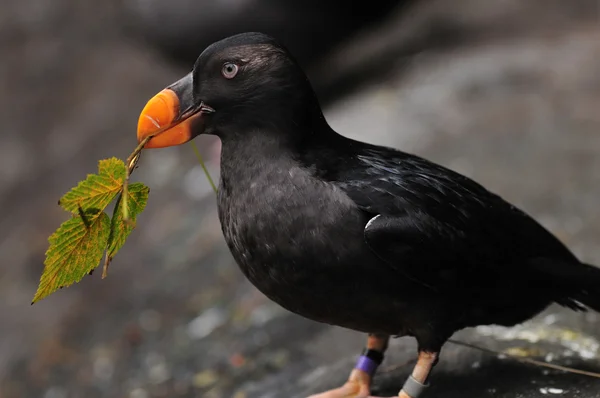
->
(537, 261, 600, 312)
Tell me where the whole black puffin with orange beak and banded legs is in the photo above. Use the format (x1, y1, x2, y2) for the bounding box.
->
(138, 33, 600, 398)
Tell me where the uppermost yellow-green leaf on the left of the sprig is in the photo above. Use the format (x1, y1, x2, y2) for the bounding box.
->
(58, 157, 125, 213)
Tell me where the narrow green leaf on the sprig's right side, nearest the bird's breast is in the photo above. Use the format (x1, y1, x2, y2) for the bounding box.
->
(102, 182, 150, 277)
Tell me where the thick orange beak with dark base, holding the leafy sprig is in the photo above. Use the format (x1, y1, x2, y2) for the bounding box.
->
(137, 73, 214, 148)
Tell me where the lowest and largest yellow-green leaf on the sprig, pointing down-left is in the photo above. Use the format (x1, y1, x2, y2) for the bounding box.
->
(32, 210, 110, 304)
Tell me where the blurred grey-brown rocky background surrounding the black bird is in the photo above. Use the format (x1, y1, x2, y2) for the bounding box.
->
(0, 0, 600, 398)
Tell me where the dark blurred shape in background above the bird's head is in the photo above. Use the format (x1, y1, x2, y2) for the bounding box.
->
(124, 0, 410, 64)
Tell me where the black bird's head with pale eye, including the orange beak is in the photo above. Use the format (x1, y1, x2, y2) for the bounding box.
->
(137, 33, 324, 148)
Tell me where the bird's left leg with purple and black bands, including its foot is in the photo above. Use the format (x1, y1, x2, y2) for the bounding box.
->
(309, 334, 390, 398)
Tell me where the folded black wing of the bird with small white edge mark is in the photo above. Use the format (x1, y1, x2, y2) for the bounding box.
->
(340, 148, 573, 289)
